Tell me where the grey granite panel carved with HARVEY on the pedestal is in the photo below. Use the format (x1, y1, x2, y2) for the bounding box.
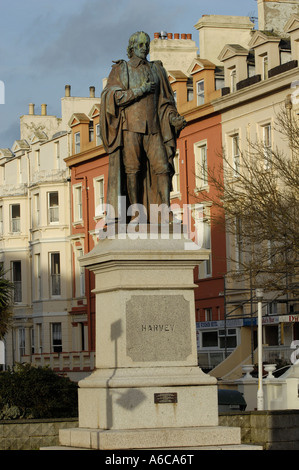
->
(126, 295, 192, 362)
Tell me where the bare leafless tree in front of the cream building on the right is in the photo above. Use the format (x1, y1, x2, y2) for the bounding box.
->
(198, 108, 299, 294)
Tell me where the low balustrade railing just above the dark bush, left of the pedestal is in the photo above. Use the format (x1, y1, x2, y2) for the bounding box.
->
(22, 351, 95, 372)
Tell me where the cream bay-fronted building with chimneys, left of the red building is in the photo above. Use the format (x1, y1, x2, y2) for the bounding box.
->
(0, 85, 98, 379)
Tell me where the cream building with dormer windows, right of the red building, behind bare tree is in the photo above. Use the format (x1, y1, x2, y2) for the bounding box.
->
(212, 9, 299, 378)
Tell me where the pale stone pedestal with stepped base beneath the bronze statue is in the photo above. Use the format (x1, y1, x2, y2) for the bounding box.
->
(60, 234, 260, 449)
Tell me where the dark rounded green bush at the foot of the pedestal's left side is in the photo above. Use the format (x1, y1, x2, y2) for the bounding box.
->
(0, 364, 78, 419)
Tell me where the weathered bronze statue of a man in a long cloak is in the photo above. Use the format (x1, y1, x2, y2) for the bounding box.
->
(100, 31, 186, 224)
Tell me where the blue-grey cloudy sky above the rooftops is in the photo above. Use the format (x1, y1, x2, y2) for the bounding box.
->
(0, 0, 257, 148)
